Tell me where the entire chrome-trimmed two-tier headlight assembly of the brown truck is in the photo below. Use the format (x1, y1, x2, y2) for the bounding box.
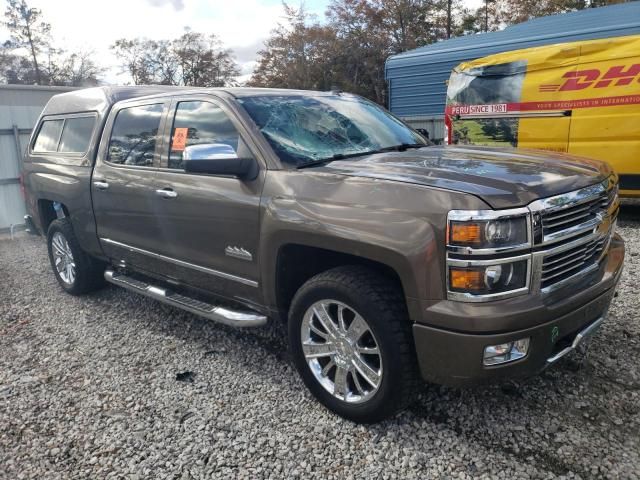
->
(447, 208, 532, 302)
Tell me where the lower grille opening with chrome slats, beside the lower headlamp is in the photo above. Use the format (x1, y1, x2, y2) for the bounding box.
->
(540, 235, 609, 289)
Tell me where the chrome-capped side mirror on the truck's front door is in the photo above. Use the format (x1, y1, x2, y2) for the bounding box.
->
(182, 143, 258, 180)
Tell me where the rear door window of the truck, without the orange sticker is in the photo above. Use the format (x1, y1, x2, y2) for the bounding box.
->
(107, 103, 164, 167)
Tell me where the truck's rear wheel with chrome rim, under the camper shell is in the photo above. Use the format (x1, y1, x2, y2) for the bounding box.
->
(47, 218, 105, 295)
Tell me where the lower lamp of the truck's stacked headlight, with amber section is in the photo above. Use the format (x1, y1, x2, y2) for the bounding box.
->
(449, 260, 528, 295)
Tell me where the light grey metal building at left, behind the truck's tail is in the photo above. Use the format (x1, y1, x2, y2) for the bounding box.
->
(0, 85, 73, 232)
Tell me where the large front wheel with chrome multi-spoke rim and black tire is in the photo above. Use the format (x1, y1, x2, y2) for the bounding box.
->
(289, 266, 417, 423)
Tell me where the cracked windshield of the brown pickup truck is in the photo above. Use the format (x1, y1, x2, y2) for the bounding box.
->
(239, 94, 427, 167)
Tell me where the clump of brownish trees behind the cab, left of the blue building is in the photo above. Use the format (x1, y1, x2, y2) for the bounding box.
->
(249, 0, 457, 103)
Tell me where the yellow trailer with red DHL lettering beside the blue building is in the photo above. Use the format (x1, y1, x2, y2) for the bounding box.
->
(445, 35, 640, 197)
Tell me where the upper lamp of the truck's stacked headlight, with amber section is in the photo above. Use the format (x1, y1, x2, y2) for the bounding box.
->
(448, 216, 528, 248)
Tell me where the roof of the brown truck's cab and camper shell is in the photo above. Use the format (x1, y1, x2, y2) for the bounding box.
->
(42, 85, 340, 115)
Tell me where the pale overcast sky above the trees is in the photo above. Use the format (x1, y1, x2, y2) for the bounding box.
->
(0, 0, 482, 83)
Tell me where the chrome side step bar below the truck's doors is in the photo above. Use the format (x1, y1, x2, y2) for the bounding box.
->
(104, 268, 267, 327)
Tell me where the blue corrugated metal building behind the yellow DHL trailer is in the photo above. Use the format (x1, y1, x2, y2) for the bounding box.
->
(385, 1, 640, 140)
